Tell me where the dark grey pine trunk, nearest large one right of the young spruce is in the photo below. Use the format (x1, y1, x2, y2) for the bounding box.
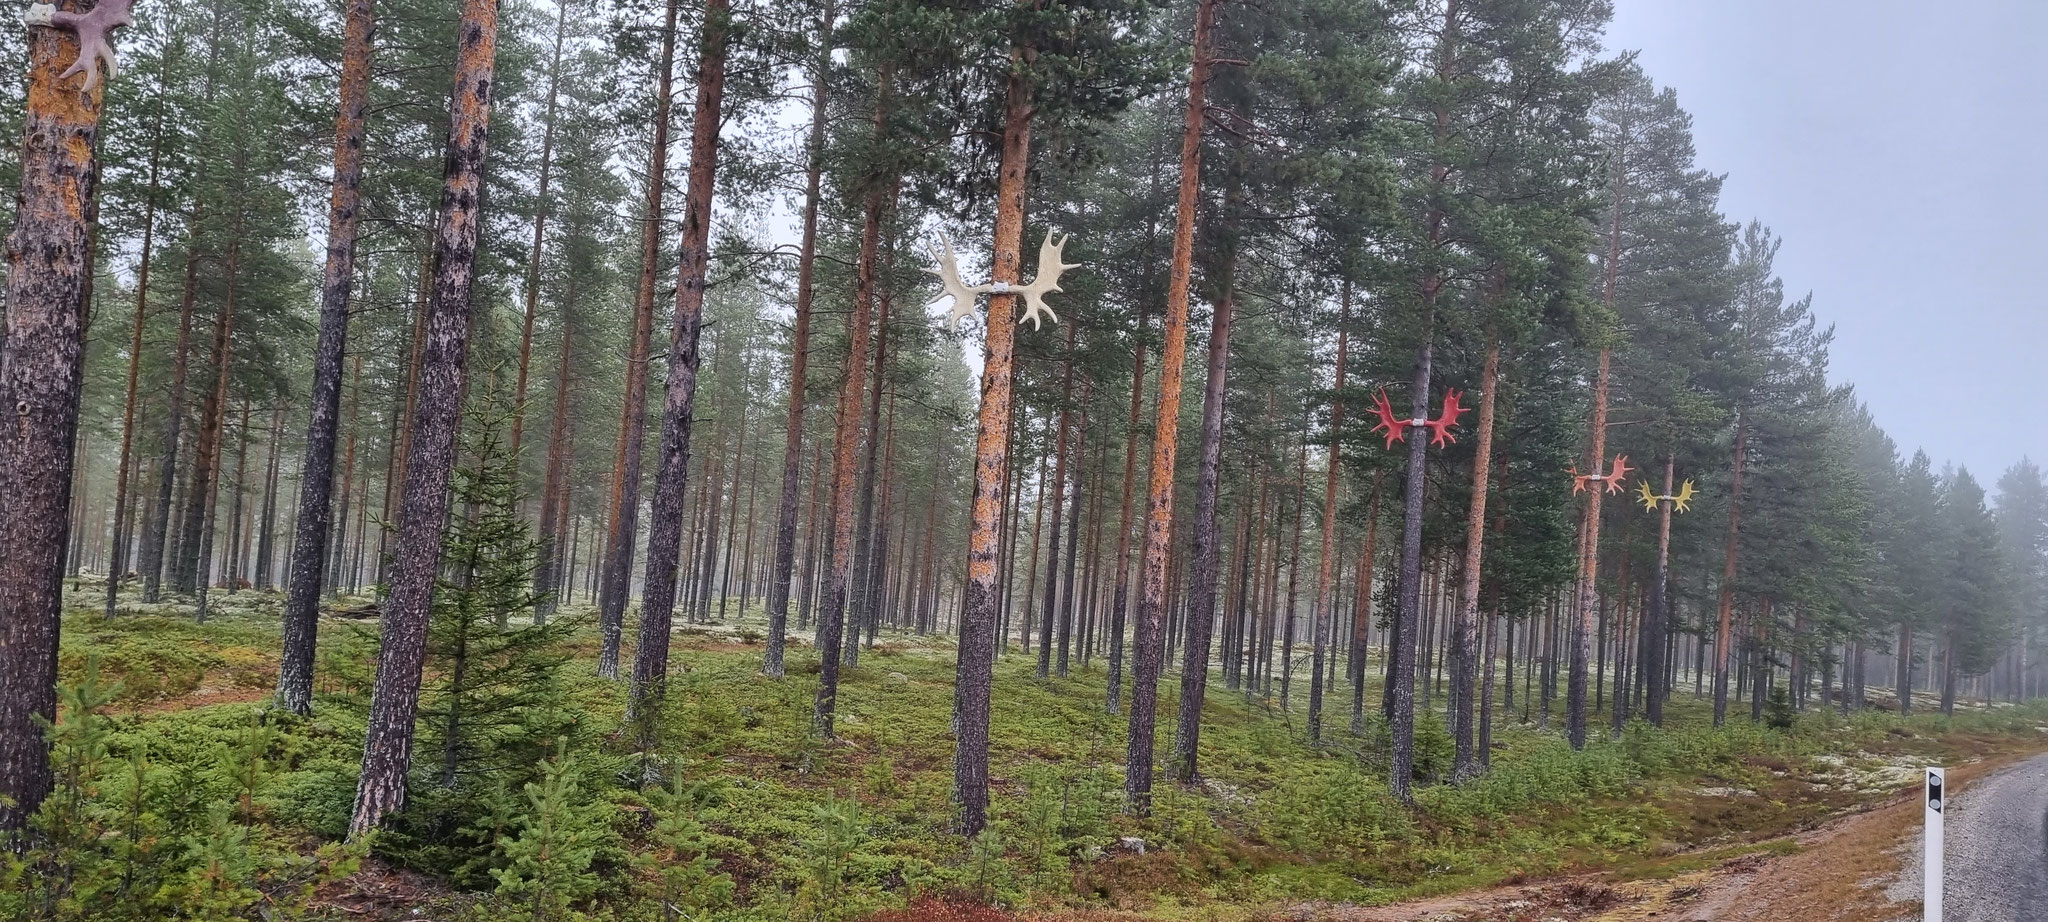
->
(612, 0, 731, 713)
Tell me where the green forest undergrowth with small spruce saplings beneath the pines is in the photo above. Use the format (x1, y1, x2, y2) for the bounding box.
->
(0, 588, 2048, 920)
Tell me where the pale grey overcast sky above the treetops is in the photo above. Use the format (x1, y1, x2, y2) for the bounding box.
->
(1608, 0, 2048, 488)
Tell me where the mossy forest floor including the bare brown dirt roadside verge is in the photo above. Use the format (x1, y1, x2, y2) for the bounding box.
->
(44, 592, 2048, 922)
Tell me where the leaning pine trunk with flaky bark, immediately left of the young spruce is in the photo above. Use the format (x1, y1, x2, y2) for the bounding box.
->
(348, 0, 498, 838)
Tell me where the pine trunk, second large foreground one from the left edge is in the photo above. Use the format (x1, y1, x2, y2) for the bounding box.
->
(276, 0, 375, 715)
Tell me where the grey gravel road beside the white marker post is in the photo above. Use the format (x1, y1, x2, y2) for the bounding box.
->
(1890, 756, 2048, 922)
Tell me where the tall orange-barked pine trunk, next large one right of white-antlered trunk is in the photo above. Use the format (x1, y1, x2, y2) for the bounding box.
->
(1124, 0, 1217, 813)
